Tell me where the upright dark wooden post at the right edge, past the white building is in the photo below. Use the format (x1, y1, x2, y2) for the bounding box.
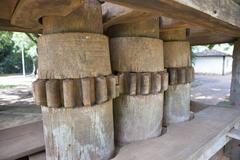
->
(230, 40, 240, 105)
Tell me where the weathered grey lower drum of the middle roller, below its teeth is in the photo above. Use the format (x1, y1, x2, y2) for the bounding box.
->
(114, 93, 163, 146)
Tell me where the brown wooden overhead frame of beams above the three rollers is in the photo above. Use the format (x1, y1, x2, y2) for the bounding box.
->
(0, 0, 240, 45)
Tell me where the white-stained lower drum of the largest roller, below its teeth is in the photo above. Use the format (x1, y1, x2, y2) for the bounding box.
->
(42, 101, 114, 160)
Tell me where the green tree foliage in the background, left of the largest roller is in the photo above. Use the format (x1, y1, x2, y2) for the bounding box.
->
(0, 32, 37, 74)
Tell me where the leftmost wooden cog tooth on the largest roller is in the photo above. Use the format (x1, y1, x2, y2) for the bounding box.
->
(32, 79, 47, 106)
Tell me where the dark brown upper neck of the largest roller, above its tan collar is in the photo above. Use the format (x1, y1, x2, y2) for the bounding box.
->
(42, 0, 103, 34)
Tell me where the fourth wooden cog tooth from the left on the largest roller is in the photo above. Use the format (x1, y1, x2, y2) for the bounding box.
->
(81, 77, 95, 106)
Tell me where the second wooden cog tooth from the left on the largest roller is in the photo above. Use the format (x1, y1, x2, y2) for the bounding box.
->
(46, 79, 62, 107)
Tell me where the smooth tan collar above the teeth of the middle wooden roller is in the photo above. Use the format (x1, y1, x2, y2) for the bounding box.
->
(110, 37, 163, 72)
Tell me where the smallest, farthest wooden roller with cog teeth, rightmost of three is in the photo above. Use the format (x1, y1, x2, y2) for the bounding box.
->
(160, 29, 192, 125)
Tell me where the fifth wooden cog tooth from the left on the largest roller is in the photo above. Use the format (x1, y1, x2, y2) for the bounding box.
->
(96, 76, 108, 104)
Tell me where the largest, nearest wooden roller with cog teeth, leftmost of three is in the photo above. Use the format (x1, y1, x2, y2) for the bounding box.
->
(37, 0, 116, 160)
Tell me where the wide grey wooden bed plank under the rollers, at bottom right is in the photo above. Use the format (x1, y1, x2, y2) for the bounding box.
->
(114, 107, 240, 160)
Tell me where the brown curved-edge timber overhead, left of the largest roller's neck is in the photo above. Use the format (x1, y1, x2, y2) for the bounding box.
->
(11, 0, 84, 28)
